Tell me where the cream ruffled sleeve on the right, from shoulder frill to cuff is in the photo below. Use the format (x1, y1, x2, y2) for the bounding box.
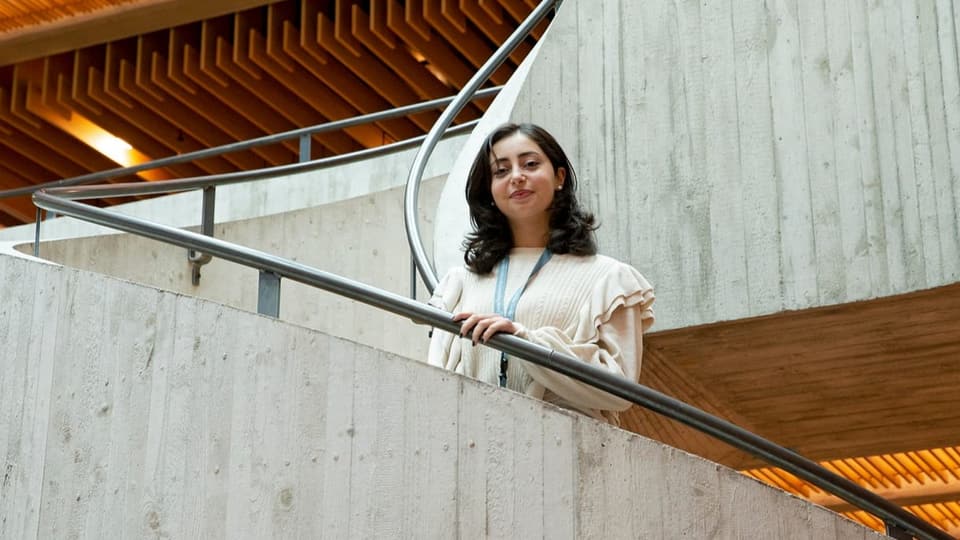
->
(517, 261, 654, 412)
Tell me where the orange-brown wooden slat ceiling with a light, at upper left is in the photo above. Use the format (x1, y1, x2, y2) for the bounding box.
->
(0, 0, 540, 226)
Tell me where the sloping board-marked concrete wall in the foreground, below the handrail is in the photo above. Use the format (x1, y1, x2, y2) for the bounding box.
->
(0, 255, 878, 540)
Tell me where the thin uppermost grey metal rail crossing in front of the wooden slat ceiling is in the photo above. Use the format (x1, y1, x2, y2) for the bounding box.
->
(0, 86, 503, 199)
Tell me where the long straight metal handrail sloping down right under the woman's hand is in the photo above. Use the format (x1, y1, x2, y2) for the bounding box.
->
(33, 188, 951, 540)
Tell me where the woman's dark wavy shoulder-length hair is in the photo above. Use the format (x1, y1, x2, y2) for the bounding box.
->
(463, 124, 597, 274)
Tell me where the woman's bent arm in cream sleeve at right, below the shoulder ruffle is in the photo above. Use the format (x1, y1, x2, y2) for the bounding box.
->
(515, 304, 645, 411)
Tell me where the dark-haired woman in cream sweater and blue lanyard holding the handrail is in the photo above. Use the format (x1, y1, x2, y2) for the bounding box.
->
(429, 124, 654, 425)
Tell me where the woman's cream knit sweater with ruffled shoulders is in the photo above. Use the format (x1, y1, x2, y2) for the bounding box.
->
(428, 248, 654, 425)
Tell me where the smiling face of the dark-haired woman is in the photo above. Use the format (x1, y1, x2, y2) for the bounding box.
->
(490, 132, 567, 233)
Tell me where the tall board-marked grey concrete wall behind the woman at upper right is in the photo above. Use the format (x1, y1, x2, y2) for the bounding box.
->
(440, 0, 960, 331)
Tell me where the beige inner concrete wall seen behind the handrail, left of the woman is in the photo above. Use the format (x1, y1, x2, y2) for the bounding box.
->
(22, 178, 443, 359)
